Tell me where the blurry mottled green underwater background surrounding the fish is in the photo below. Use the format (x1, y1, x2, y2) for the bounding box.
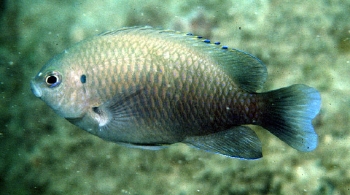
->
(0, 0, 350, 195)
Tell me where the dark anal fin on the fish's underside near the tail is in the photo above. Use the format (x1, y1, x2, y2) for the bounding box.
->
(183, 126, 262, 159)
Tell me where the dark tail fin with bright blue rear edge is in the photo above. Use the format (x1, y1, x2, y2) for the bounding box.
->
(261, 84, 321, 151)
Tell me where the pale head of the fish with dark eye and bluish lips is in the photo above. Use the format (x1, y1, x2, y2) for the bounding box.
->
(30, 54, 88, 119)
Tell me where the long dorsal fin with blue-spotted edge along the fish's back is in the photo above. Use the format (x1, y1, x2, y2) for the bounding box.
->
(98, 26, 267, 92)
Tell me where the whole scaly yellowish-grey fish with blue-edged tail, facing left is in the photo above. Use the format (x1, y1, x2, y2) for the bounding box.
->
(30, 26, 321, 159)
